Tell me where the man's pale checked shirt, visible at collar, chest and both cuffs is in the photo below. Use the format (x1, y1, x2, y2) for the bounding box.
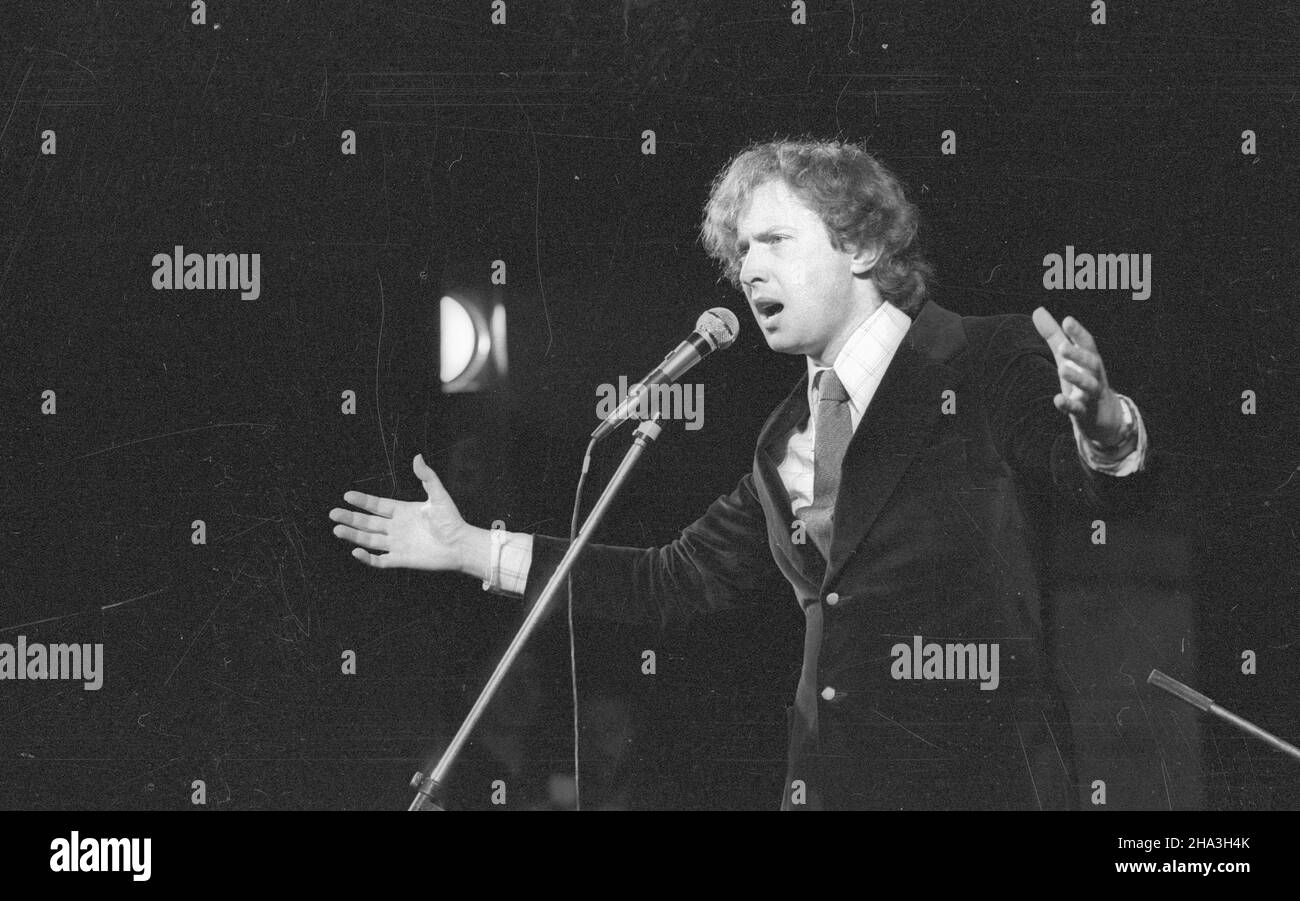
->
(494, 300, 1147, 594)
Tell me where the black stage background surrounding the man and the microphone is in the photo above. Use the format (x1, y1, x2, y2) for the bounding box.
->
(0, 0, 1300, 809)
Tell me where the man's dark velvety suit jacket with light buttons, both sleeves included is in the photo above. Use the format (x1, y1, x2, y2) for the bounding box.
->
(525, 302, 1151, 810)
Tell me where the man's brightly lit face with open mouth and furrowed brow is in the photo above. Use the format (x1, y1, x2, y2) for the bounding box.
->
(736, 178, 863, 365)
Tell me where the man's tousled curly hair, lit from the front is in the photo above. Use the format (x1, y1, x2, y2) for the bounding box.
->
(699, 139, 935, 315)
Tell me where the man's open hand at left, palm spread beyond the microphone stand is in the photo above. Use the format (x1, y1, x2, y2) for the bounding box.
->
(329, 455, 486, 573)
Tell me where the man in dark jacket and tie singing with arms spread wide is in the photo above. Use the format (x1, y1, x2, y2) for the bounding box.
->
(330, 142, 1147, 810)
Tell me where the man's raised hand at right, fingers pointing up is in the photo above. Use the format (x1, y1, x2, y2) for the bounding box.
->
(1034, 307, 1125, 447)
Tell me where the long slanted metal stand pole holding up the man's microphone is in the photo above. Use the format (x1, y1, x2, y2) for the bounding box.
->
(407, 419, 663, 810)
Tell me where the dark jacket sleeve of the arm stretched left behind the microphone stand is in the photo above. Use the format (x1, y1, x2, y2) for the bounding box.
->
(524, 475, 775, 627)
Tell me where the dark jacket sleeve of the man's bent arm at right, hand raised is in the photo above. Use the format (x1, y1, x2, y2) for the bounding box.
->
(978, 316, 1160, 514)
